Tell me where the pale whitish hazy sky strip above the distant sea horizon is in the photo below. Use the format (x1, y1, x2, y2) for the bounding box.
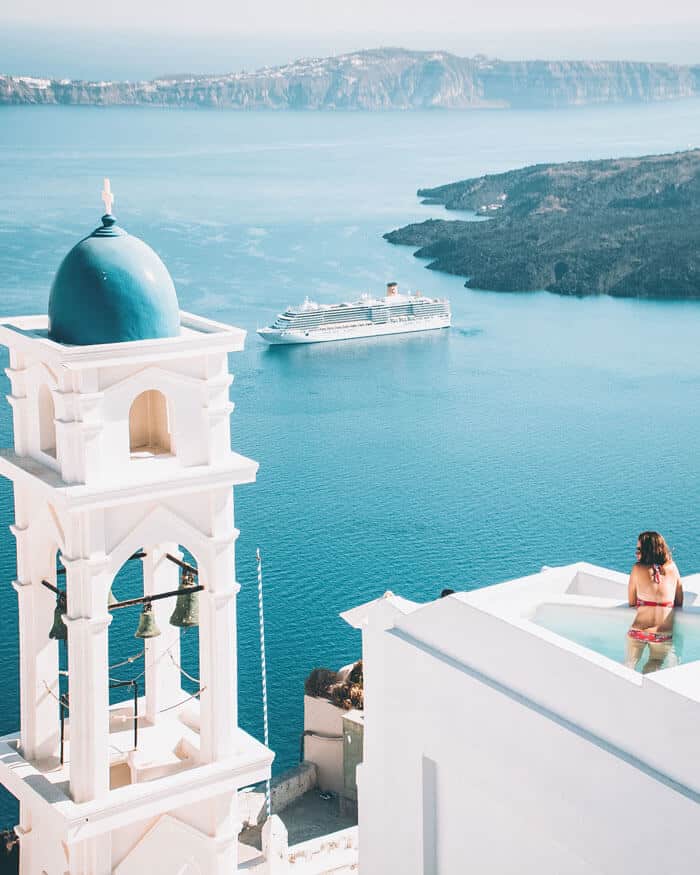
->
(5, 0, 700, 35)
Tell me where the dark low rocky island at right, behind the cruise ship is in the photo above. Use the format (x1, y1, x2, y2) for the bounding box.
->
(384, 149, 700, 298)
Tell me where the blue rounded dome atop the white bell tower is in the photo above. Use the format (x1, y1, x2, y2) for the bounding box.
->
(49, 215, 180, 346)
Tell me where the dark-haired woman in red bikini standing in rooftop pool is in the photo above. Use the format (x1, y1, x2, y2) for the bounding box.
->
(625, 532, 683, 674)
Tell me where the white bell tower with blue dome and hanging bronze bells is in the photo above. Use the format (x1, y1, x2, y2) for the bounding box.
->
(0, 188, 273, 875)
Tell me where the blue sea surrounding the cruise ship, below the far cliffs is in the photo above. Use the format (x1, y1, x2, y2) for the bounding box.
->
(0, 101, 700, 825)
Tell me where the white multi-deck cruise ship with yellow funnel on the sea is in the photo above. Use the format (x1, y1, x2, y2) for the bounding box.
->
(258, 283, 452, 344)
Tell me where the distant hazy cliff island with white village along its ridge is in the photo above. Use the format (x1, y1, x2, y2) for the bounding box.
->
(0, 48, 700, 110)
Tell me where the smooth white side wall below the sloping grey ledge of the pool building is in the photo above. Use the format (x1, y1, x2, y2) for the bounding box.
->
(359, 635, 700, 875)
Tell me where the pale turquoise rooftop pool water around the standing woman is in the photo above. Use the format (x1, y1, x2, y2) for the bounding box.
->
(533, 604, 700, 672)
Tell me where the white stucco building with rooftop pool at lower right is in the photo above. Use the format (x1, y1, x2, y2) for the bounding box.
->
(343, 563, 700, 875)
